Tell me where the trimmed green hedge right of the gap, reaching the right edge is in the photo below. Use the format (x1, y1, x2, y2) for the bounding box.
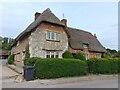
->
(87, 58, 120, 74)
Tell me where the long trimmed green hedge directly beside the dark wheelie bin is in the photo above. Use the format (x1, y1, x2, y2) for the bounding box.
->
(34, 58, 86, 79)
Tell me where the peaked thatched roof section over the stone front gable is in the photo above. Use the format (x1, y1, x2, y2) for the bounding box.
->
(16, 8, 64, 40)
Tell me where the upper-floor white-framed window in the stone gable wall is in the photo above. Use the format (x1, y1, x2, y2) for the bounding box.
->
(46, 31, 61, 41)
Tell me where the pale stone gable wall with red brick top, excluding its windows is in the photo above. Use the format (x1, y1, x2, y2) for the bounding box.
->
(29, 23, 68, 58)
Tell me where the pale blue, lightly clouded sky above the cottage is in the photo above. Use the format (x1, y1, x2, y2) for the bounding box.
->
(0, 2, 118, 50)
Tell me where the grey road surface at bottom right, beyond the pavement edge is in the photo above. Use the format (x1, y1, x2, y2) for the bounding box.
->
(43, 79, 118, 88)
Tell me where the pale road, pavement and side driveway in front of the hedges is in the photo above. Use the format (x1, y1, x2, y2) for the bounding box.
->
(2, 61, 118, 88)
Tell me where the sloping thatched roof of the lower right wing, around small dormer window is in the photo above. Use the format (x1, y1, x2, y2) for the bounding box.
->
(66, 27, 105, 52)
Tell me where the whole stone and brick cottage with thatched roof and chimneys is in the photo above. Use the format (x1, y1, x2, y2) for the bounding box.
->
(12, 8, 105, 63)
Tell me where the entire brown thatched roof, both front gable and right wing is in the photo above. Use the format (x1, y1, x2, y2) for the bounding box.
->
(16, 8, 105, 52)
